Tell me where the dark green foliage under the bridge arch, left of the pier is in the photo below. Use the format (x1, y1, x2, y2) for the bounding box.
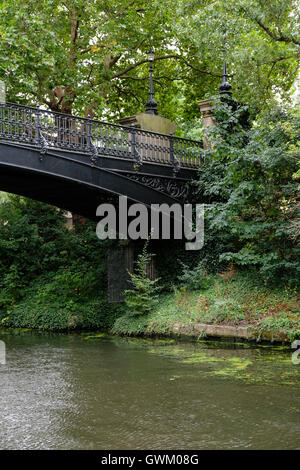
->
(0, 195, 123, 329)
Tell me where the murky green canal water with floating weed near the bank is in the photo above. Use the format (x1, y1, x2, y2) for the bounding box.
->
(0, 330, 300, 450)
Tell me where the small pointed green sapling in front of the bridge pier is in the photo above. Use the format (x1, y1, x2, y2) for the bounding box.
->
(124, 240, 158, 315)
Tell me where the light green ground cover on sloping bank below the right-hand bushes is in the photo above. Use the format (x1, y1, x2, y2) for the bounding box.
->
(112, 273, 300, 340)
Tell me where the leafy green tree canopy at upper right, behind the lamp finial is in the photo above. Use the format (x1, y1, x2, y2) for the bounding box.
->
(176, 0, 300, 117)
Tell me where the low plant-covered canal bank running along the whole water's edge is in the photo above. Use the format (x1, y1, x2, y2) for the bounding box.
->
(0, 275, 300, 343)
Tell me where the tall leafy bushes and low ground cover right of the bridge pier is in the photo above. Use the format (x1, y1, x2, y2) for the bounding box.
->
(113, 97, 300, 339)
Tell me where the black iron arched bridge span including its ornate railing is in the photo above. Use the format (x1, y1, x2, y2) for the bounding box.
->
(0, 103, 202, 219)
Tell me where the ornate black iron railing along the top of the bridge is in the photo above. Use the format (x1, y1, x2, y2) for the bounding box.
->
(0, 103, 202, 171)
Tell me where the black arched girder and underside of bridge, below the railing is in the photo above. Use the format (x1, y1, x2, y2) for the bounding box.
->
(0, 141, 195, 220)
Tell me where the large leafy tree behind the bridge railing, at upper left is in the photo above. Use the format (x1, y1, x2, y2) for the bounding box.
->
(0, 0, 185, 117)
